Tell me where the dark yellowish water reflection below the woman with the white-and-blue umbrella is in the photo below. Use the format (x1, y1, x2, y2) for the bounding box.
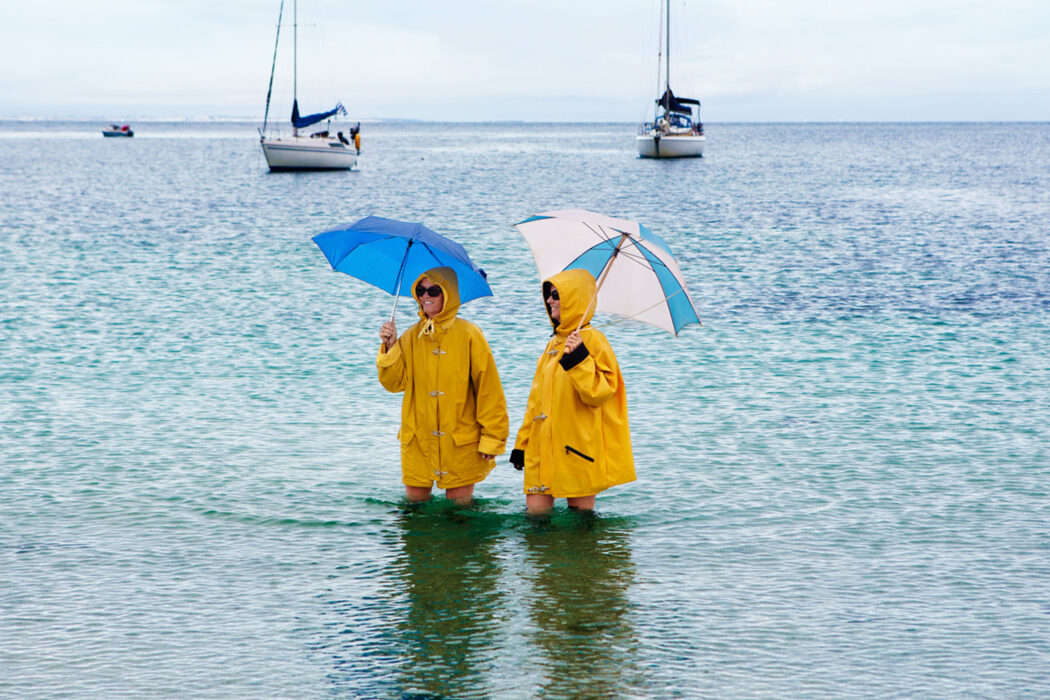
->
(525, 513, 641, 698)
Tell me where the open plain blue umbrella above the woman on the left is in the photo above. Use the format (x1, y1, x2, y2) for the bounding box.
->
(313, 216, 492, 317)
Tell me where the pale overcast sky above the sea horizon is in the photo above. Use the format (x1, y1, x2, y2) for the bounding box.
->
(0, 0, 1050, 123)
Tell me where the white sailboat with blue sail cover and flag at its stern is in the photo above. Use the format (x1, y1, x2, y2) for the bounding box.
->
(259, 0, 361, 171)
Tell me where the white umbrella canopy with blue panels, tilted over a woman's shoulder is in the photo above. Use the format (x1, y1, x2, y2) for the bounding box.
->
(515, 209, 700, 335)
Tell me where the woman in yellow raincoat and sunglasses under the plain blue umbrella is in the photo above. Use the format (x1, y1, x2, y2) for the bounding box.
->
(376, 268, 508, 504)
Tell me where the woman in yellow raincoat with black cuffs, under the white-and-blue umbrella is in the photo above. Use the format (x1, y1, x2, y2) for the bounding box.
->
(510, 270, 634, 514)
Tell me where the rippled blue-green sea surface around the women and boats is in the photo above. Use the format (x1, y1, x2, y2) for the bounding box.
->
(0, 122, 1050, 699)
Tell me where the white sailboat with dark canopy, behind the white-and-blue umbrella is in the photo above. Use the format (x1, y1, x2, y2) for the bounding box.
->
(637, 0, 707, 158)
